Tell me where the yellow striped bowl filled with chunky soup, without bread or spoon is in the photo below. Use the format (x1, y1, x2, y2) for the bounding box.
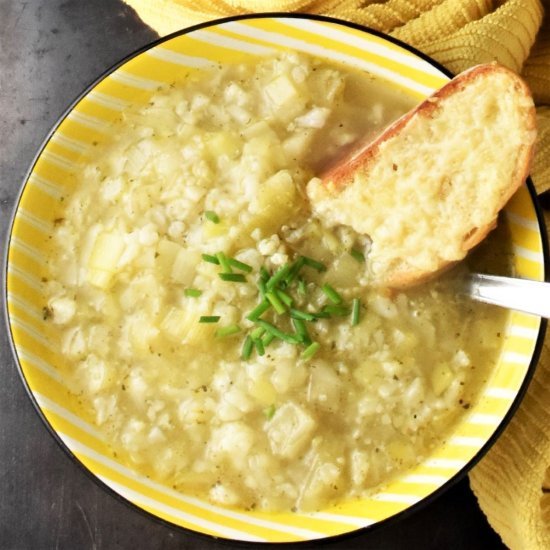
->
(7, 14, 546, 543)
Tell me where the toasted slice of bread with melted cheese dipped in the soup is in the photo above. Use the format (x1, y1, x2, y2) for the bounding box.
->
(307, 63, 536, 287)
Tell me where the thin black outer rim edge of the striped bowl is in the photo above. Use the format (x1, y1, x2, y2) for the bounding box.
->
(3, 12, 550, 548)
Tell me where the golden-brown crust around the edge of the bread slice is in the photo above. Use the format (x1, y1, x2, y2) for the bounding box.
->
(313, 63, 536, 287)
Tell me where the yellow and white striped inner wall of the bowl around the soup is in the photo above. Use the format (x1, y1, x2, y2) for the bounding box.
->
(6, 14, 546, 543)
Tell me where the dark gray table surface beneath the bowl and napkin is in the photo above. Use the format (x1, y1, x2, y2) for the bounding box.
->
(0, 0, 504, 550)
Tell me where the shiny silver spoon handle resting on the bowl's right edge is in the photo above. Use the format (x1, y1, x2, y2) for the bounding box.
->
(464, 273, 550, 319)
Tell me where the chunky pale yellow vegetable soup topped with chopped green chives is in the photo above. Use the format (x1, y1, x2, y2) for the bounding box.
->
(43, 52, 508, 511)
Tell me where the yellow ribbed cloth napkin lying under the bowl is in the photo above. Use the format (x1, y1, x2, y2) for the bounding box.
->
(125, 0, 550, 550)
